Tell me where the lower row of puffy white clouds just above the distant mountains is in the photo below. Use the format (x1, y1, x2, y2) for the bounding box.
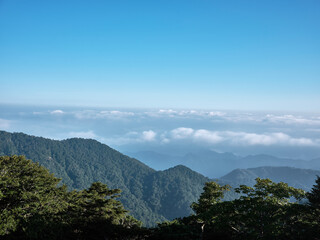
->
(69, 127, 320, 147)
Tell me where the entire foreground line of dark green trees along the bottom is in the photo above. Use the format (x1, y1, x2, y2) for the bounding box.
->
(0, 156, 320, 240)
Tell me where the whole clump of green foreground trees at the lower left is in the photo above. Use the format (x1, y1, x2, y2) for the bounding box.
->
(0, 156, 141, 239)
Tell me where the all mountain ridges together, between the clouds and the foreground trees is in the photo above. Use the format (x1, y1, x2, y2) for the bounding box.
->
(0, 131, 320, 226)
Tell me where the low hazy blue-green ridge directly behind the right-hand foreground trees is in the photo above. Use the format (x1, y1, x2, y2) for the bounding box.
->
(220, 167, 320, 191)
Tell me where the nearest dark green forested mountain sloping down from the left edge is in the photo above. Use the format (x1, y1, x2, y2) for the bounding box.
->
(0, 131, 210, 226)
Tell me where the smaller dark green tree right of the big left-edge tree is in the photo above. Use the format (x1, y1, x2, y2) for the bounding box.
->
(65, 182, 142, 239)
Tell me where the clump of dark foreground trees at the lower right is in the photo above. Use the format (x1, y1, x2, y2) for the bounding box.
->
(186, 178, 320, 239)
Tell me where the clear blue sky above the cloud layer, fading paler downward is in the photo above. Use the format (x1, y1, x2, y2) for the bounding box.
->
(0, 0, 320, 111)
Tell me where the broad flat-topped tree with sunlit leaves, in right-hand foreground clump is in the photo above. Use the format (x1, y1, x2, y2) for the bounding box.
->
(228, 178, 305, 239)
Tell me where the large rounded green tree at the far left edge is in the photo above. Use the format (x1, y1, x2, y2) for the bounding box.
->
(0, 156, 67, 238)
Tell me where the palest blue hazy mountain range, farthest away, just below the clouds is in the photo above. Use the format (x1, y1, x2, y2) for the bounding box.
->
(127, 150, 320, 178)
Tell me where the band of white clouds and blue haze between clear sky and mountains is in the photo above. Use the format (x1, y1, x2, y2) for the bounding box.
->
(0, 105, 320, 159)
